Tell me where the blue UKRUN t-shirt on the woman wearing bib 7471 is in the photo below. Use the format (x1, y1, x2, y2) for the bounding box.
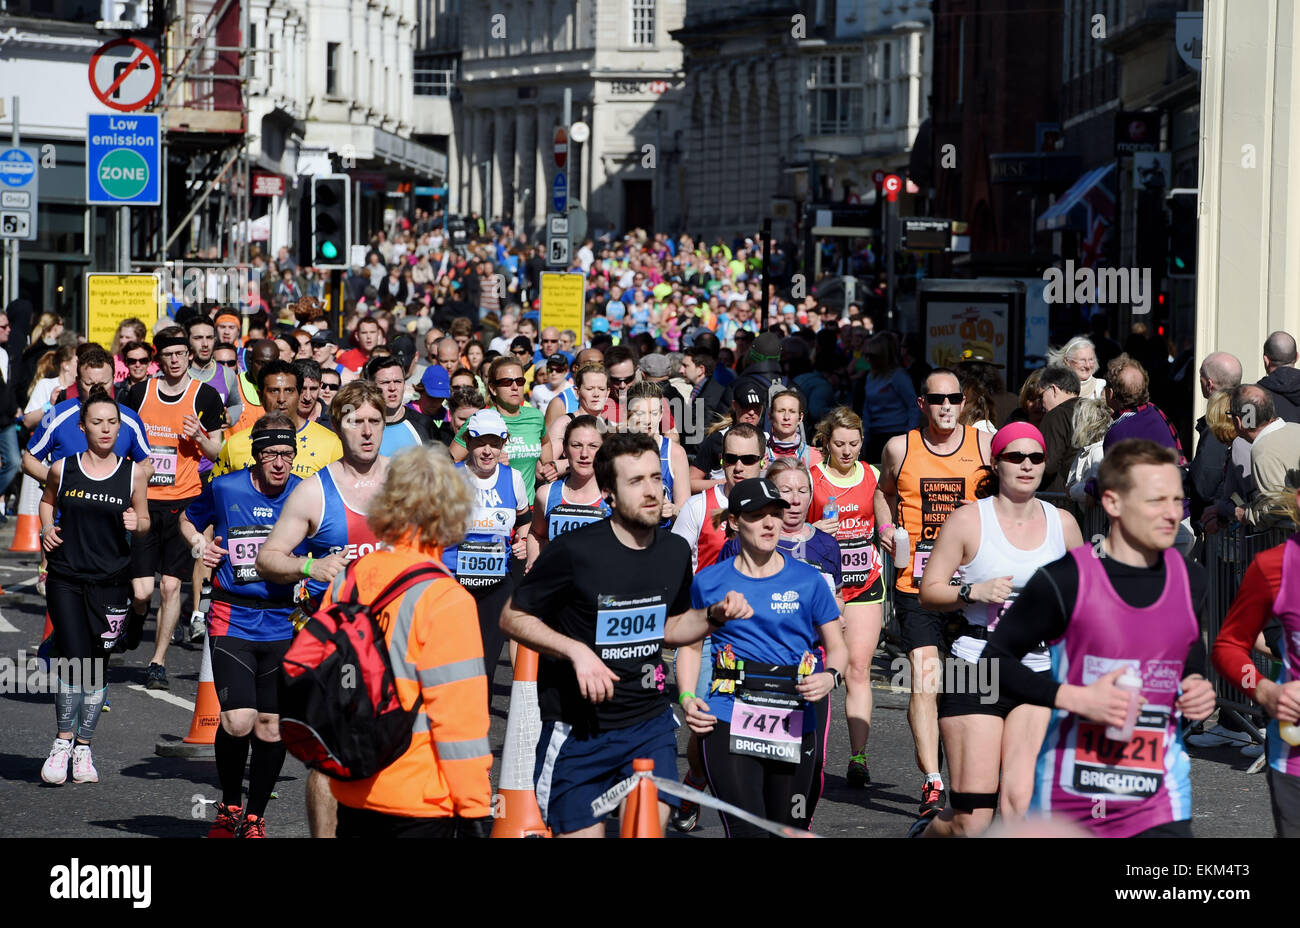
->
(690, 555, 840, 733)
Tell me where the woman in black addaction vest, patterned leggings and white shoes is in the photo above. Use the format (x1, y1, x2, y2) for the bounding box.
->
(40, 387, 150, 784)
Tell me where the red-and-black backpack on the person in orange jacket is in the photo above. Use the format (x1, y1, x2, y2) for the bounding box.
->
(280, 561, 454, 780)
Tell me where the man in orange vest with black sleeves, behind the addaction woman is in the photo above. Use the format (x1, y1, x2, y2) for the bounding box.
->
(122, 326, 226, 690)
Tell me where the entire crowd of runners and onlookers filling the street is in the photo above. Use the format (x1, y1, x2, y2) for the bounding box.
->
(10, 217, 1300, 837)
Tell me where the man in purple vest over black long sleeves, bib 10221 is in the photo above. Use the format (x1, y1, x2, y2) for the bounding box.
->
(984, 438, 1216, 837)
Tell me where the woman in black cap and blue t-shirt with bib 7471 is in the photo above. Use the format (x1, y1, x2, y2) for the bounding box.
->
(677, 477, 849, 837)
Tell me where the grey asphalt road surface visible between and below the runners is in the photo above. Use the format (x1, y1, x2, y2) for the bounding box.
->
(0, 519, 1273, 838)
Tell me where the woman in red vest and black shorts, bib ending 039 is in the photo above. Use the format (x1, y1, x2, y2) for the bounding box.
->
(811, 405, 885, 789)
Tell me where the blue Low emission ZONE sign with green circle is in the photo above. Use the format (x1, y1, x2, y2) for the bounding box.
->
(86, 113, 160, 207)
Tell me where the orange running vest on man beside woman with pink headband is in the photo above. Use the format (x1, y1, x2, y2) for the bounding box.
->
(894, 425, 985, 594)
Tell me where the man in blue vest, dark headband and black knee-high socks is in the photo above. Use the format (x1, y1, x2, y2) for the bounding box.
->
(181, 412, 302, 838)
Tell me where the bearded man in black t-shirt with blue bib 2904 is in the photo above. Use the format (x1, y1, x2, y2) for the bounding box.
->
(501, 433, 753, 837)
